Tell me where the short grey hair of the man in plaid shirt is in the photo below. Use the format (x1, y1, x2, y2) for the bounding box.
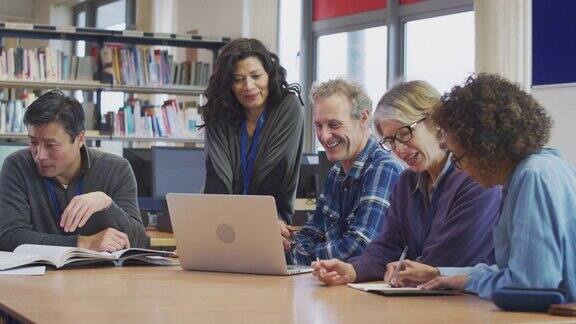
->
(310, 78, 372, 119)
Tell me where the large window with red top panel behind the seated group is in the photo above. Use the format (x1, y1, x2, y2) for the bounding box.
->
(278, 0, 475, 152)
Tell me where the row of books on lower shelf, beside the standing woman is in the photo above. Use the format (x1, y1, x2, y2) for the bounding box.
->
(106, 99, 200, 138)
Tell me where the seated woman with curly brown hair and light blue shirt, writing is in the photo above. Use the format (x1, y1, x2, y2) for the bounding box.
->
(382, 74, 576, 301)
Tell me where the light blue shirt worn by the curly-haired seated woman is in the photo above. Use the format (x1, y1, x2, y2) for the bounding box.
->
(440, 149, 576, 302)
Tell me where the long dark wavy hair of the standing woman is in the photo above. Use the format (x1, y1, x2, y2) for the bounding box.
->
(200, 38, 300, 127)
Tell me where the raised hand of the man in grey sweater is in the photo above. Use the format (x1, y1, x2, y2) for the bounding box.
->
(60, 191, 112, 232)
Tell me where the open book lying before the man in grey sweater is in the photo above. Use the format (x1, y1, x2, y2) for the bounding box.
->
(0, 244, 178, 270)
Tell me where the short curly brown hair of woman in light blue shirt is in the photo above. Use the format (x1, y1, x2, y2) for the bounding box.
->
(432, 73, 553, 172)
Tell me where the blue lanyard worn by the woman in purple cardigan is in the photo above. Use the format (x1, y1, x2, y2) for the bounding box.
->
(412, 164, 454, 256)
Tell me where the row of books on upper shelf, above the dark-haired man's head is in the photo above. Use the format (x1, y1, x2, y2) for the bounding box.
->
(0, 47, 96, 82)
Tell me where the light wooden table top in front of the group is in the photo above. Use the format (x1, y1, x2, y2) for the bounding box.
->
(0, 267, 574, 324)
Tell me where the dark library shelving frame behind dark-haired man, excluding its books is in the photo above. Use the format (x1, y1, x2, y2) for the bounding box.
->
(0, 22, 230, 144)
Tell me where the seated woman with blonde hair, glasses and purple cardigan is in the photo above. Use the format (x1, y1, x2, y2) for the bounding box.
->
(312, 81, 501, 285)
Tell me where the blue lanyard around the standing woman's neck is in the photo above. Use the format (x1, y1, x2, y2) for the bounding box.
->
(240, 109, 266, 195)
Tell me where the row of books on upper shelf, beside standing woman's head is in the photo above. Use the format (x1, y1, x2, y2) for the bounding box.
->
(100, 45, 210, 86)
